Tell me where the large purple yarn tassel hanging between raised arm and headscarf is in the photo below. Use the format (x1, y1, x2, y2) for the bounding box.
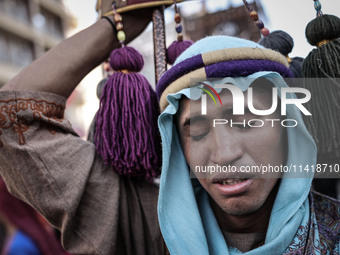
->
(94, 46, 161, 181)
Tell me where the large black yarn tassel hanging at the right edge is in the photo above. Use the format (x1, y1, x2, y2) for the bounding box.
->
(302, 15, 340, 157)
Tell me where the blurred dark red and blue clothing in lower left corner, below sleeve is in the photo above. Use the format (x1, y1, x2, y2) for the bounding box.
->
(0, 179, 69, 255)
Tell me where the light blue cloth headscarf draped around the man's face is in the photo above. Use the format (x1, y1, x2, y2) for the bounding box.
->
(158, 37, 316, 255)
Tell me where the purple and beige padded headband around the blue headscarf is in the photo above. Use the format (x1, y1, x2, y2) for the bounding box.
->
(156, 44, 293, 112)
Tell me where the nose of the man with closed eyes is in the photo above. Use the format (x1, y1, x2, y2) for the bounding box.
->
(210, 126, 243, 165)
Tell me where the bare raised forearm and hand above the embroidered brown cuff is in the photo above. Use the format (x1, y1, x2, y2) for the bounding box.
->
(0, 10, 151, 97)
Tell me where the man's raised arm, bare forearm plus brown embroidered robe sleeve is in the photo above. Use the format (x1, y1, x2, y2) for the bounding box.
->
(0, 8, 164, 255)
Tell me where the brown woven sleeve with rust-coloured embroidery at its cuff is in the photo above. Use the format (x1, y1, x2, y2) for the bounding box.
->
(0, 91, 120, 254)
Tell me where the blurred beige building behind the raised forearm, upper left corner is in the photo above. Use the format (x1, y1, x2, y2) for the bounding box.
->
(0, 0, 72, 86)
